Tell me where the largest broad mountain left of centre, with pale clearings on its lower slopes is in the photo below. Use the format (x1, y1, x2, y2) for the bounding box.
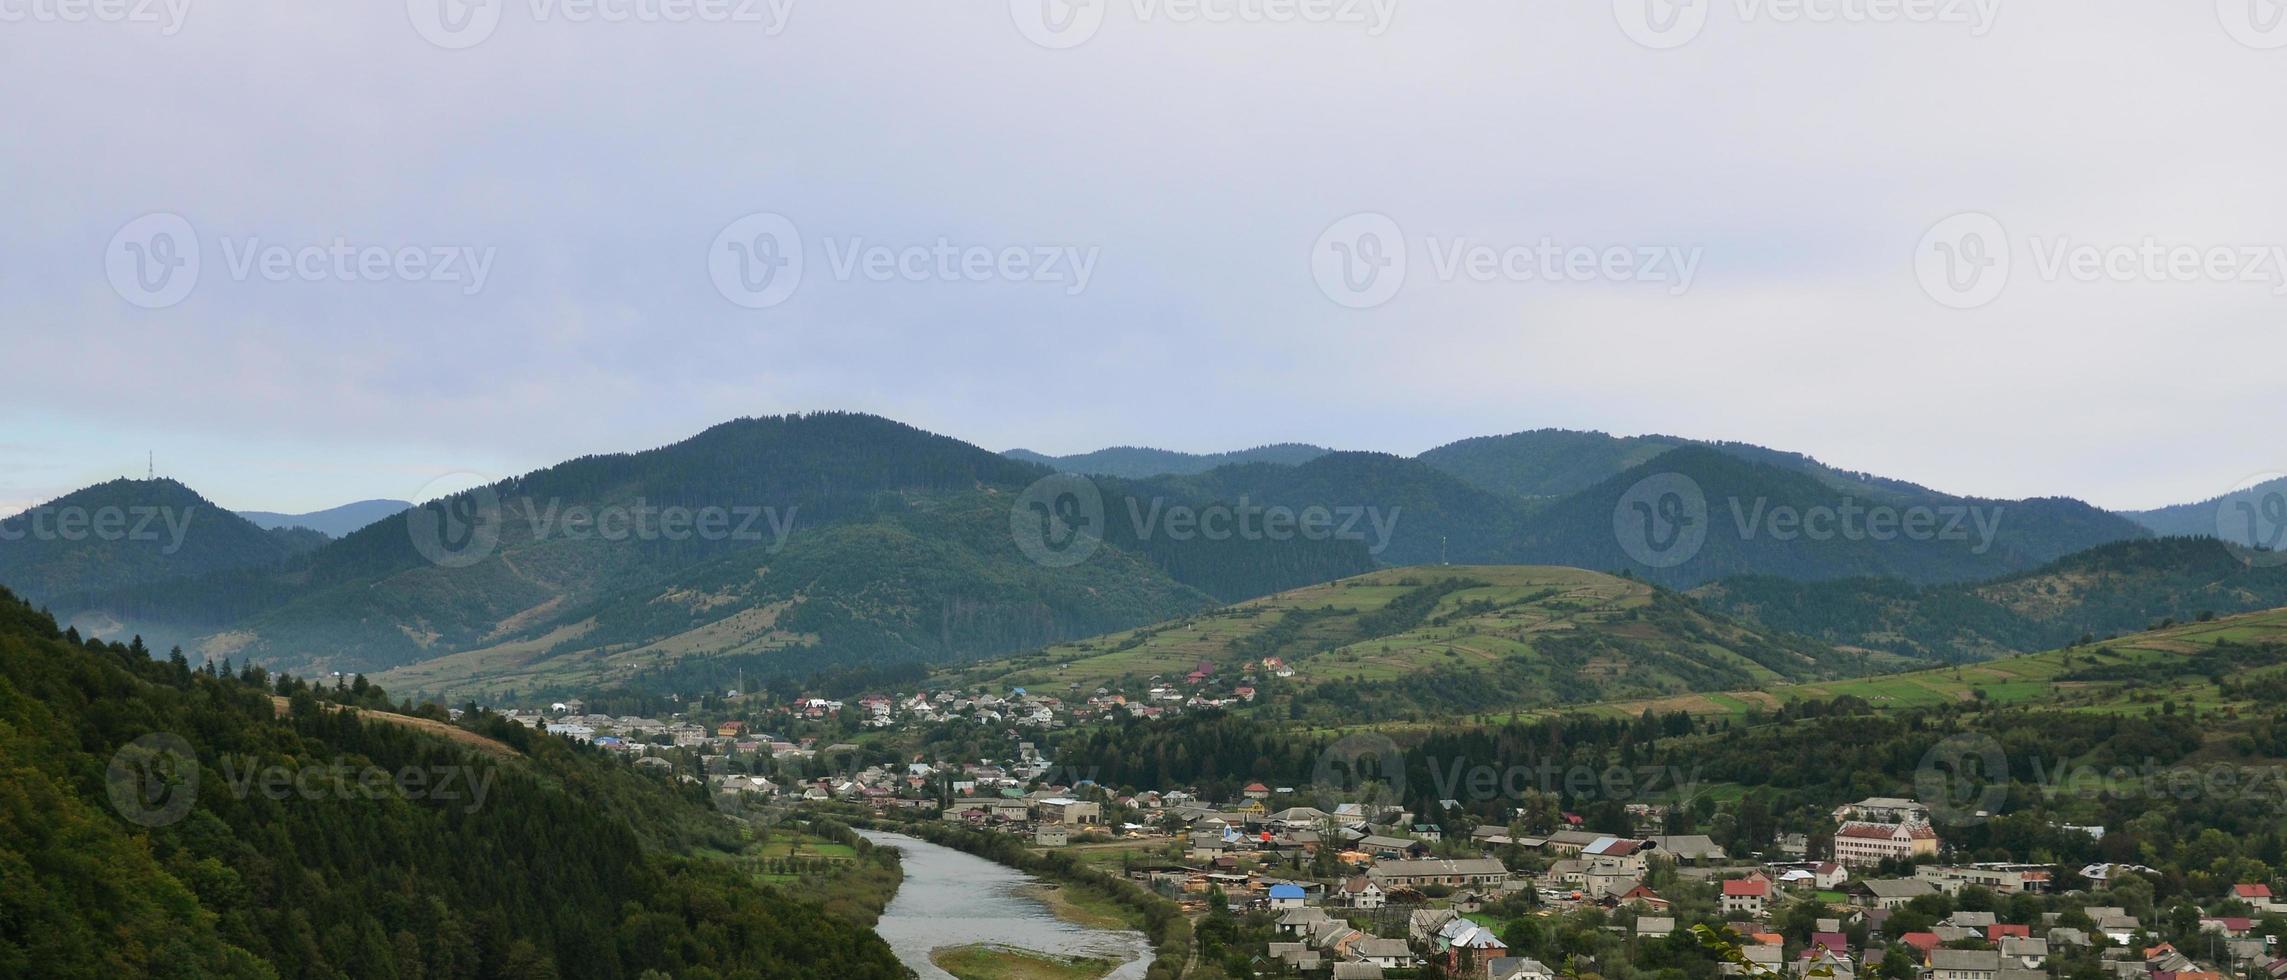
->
(57, 413, 1370, 694)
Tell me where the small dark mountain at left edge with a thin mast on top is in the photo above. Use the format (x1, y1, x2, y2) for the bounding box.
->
(0, 480, 316, 601)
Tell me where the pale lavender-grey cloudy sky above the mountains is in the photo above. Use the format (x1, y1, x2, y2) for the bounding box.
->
(0, 0, 2287, 514)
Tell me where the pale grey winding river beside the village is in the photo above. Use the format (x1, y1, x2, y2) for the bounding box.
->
(864, 832, 1150, 980)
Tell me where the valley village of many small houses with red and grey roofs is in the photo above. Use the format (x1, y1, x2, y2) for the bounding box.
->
(477, 692, 2287, 980)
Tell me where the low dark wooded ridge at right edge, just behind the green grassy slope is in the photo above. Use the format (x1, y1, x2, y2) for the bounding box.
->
(1692, 537, 2287, 662)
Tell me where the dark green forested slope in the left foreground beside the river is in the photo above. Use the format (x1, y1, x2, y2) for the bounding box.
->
(0, 589, 906, 980)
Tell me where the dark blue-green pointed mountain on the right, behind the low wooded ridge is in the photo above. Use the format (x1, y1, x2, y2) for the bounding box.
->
(1521, 445, 2150, 587)
